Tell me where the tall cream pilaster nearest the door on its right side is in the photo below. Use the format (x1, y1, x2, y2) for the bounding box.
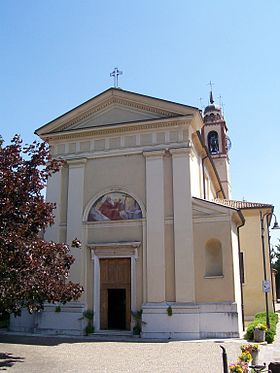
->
(143, 150, 165, 302)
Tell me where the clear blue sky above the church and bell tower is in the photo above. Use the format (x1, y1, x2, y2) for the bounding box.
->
(0, 0, 280, 242)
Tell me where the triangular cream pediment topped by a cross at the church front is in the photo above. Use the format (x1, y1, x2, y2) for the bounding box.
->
(36, 88, 198, 136)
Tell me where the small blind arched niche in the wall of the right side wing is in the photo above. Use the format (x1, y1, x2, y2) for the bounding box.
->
(205, 239, 223, 277)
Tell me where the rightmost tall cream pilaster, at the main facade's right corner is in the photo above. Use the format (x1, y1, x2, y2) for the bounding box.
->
(170, 148, 195, 302)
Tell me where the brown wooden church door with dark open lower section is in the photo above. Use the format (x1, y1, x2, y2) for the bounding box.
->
(100, 258, 131, 330)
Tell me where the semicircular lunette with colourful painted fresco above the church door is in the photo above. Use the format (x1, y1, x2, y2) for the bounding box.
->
(88, 192, 142, 221)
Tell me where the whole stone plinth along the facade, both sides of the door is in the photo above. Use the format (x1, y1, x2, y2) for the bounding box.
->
(10, 302, 241, 340)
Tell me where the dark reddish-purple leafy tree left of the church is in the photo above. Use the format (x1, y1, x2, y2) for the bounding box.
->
(0, 135, 83, 315)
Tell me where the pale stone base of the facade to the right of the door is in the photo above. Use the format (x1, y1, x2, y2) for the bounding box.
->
(141, 302, 241, 340)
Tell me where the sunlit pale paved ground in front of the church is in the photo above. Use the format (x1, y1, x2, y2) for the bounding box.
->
(0, 306, 280, 373)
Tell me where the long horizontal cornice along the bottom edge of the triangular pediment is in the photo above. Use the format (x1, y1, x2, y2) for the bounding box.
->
(41, 116, 192, 140)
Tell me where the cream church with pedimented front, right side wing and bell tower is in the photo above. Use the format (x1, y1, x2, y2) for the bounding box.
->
(9, 88, 271, 339)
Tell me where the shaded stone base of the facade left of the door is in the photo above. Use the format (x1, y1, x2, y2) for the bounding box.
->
(10, 302, 87, 335)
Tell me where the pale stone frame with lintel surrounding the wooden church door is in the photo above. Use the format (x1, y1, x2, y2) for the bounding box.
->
(88, 241, 141, 333)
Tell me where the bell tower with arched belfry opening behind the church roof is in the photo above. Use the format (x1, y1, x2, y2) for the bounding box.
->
(202, 89, 231, 199)
